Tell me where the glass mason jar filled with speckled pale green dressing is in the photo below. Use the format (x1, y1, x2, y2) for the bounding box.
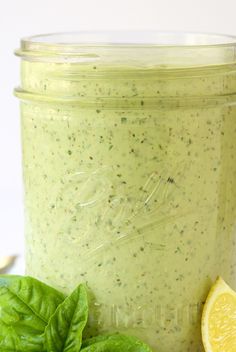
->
(16, 32, 236, 352)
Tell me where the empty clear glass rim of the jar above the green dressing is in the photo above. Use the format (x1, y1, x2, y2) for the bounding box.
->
(15, 31, 236, 68)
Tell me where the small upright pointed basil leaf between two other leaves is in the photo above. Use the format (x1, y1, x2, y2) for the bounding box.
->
(45, 285, 88, 352)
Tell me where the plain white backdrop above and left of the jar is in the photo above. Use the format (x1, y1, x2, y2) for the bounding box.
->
(0, 0, 236, 262)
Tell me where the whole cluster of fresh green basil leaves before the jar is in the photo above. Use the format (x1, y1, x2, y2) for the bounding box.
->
(0, 275, 152, 352)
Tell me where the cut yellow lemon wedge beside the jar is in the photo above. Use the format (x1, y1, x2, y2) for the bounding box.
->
(202, 277, 236, 352)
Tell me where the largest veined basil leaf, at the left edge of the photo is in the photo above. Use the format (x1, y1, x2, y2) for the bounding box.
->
(0, 275, 64, 352)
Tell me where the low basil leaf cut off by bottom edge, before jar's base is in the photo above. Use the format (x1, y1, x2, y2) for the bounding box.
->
(81, 333, 152, 352)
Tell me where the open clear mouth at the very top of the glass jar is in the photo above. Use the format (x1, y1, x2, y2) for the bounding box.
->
(18, 30, 236, 49)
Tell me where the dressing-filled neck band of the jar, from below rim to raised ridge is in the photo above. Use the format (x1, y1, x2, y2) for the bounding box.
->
(16, 60, 236, 108)
